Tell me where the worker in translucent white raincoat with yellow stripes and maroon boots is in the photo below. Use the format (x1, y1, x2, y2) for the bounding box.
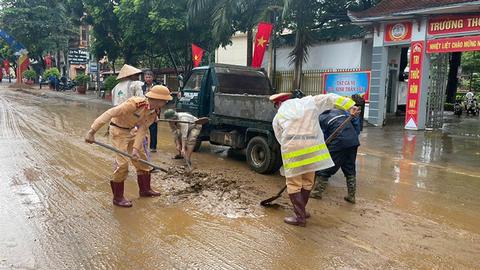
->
(270, 93, 358, 226)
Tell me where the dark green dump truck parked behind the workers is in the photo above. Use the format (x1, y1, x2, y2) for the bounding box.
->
(176, 64, 282, 174)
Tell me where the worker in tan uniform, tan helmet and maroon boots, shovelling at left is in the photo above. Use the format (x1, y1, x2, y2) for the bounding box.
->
(85, 85, 172, 207)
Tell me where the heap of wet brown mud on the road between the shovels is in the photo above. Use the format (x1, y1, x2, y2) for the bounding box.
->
(159, 167, 263, 218)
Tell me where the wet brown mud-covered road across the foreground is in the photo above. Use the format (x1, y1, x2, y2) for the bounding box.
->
(0, 88, 480, 269)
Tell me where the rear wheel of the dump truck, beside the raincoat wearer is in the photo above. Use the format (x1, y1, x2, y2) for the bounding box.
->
(247, 136, 277, 174)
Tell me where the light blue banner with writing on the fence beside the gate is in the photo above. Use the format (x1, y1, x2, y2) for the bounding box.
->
(323, 71, 370, 100)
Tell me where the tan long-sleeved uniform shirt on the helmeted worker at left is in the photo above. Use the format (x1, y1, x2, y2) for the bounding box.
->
(91, 97, 157, 150)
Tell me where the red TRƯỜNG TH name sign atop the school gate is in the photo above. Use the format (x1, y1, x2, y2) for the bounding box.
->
(428, 14, 480, 36)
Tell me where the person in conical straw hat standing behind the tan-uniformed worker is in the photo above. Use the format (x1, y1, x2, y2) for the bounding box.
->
(112, 64, 144, 106)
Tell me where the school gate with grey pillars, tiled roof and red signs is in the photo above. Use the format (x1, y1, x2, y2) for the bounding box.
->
(349, 0, 480, 130)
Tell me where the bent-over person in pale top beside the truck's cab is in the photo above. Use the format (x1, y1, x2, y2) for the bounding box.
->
(164, 109, 202, 169)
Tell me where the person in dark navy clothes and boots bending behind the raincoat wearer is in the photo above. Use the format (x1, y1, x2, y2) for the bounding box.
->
(310, 109, 360, 203)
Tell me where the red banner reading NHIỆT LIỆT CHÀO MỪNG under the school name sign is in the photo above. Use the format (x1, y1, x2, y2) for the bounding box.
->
(427, 36, 480, 53)
